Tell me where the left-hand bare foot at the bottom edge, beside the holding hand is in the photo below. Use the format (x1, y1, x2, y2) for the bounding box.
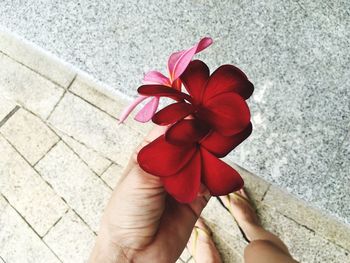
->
(187, 218, 222, 263)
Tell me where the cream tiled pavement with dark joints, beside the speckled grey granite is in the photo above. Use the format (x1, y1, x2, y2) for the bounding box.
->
(0, 31, 350, 263)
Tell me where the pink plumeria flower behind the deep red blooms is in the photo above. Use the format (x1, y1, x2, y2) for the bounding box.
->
(119, 37, 213, 123)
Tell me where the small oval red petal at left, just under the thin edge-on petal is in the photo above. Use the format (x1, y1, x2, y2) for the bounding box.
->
(152, 102, 194, 125)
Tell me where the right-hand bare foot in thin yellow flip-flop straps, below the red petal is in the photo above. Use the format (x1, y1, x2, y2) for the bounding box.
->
(220, 189, 260, 240)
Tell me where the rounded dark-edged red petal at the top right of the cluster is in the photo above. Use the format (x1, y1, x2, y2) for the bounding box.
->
(204, 65, 254, 100)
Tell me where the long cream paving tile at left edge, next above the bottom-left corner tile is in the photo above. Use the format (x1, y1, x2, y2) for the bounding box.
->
(0, 136, 67, 236)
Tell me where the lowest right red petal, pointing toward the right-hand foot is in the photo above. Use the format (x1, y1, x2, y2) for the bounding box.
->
(201, 148, 244, 196)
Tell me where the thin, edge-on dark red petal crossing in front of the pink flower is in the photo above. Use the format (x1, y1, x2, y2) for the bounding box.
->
(137, 85, 192, 101)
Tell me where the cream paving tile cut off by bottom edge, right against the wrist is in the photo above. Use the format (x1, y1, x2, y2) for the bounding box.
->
(44, 210, 95, 263)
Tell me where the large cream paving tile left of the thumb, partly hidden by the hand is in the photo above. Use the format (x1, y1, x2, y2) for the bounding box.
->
(35, 142, 111, 231)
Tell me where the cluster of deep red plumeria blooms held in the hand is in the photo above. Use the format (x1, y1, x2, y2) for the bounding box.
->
(138, 60, 253, 203)
